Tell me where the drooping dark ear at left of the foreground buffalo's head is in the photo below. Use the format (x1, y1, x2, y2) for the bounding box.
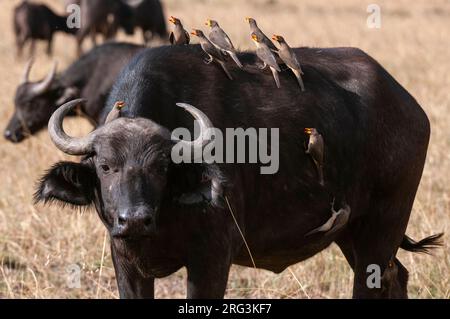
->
(34, 162, 96, 206)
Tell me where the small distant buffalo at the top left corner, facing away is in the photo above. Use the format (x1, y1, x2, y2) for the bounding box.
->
(14, 0, 77, 56)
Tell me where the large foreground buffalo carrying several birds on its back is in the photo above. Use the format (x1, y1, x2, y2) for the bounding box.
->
(35, 45, 441, 298)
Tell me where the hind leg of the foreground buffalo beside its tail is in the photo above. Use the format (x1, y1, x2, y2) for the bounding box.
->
(351, 198, 412, 298)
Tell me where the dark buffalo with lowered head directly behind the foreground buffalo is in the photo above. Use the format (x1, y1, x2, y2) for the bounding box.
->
(4, 43, 143, 143)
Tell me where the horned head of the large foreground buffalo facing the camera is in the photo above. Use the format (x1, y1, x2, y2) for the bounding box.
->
(36, 100, 223, 238)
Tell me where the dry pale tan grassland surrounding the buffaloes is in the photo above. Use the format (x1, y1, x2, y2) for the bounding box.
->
(0, 0, 450, 298)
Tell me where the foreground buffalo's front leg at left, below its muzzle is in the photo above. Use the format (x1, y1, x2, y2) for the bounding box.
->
(111, 244, 155, 299)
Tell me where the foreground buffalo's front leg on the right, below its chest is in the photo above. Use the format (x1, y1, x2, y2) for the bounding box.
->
(187, 249, 231, 299)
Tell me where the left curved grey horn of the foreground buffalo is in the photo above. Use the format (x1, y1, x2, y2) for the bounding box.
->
(48, 99, 96, 155)
